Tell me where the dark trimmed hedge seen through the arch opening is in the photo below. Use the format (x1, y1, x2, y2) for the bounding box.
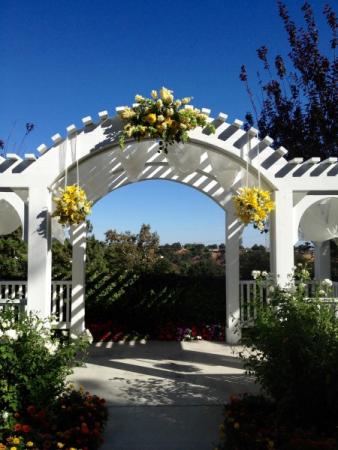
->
(86, 272, 225, 334)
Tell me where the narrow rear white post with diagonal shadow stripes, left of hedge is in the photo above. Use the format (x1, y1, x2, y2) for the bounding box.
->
(71, 222, 87, 334)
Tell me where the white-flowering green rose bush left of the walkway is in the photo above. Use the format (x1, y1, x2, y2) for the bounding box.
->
(0, 308, 86, 422)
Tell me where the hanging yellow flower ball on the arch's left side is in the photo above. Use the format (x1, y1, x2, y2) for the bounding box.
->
(53, 184, 92, 226)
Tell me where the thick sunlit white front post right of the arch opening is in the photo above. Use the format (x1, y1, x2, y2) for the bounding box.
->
(270, 190, 294, 286)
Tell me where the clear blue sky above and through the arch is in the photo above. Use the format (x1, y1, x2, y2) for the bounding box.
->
(0, 0, 329, 245)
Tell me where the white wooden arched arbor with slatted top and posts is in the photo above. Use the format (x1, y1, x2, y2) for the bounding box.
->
(0, 108, 338, 343)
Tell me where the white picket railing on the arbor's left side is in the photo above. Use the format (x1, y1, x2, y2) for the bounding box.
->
(0, 281, 72, 329)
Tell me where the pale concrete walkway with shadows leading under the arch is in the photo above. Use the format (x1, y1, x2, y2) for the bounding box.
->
(71, 341, 257, 450)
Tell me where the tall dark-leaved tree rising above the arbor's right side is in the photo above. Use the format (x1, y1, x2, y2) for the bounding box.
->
(240, 1, 338, 158)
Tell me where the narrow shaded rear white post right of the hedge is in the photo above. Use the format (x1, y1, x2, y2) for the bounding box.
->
(225, 204, 243, 344)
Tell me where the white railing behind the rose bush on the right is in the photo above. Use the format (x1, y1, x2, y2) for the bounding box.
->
(239, 280, 338, 326)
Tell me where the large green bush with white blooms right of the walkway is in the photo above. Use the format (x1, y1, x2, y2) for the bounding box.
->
(242, 267, 338, 430)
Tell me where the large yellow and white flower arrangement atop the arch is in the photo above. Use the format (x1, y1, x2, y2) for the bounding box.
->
(119, 87, 215, 153)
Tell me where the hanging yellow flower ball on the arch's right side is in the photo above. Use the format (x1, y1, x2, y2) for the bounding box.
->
(233, 187, 275, 233)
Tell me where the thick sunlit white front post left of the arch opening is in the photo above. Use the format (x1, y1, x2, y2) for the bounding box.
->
(27, 188, 52, 317)
